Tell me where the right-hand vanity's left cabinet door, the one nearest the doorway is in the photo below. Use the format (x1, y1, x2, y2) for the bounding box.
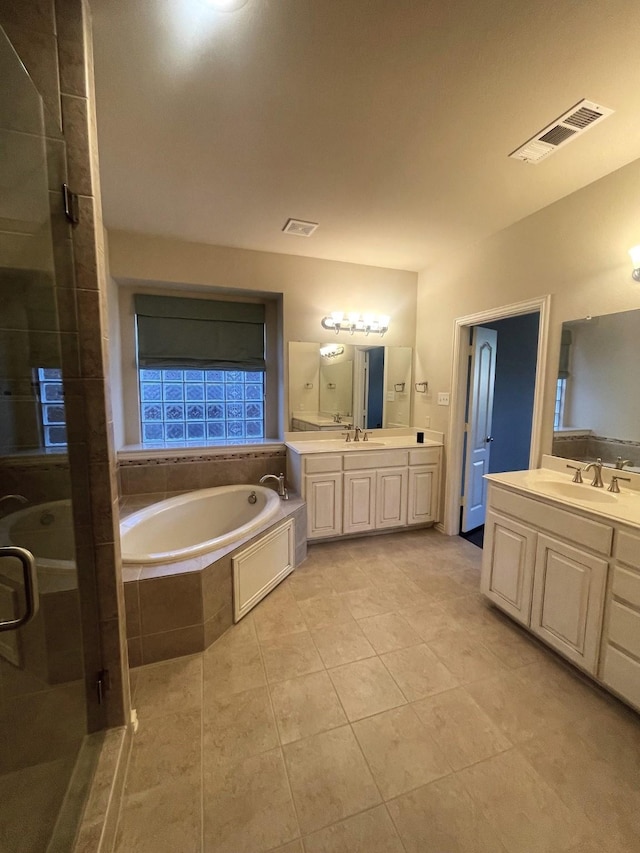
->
(480, 510, 537, 625)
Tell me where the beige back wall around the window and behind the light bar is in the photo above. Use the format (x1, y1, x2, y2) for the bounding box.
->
(109, 231, 418, 446)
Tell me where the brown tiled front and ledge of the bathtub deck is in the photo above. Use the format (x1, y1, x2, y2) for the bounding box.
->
(122, 490, 307, 667)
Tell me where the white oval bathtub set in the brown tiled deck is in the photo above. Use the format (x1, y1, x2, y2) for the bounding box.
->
(120, 485, 280, 566)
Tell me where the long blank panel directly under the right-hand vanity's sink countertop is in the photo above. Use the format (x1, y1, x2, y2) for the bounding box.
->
(489, 488, 613, 556)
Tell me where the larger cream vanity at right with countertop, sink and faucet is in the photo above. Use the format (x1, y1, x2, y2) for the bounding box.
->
(481, 457, 640, 710)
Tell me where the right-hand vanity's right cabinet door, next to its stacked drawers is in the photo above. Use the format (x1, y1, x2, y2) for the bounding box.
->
(531, 535, 608, 673)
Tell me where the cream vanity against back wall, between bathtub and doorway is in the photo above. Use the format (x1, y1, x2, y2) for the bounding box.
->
(286, 433, 442, 541)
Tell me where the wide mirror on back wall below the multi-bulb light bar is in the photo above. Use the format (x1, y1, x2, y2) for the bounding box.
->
(289, 341, 412, 431)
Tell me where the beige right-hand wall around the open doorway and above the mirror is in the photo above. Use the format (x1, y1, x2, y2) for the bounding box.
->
(414, 154, 640, 452)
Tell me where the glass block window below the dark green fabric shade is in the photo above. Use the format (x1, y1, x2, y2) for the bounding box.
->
(138, 368, 264, 445)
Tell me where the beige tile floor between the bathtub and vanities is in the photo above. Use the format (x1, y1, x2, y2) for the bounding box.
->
(117, 530, 640, 853)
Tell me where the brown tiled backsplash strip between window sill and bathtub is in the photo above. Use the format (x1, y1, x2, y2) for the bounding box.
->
(118, 445, 287, 496)
